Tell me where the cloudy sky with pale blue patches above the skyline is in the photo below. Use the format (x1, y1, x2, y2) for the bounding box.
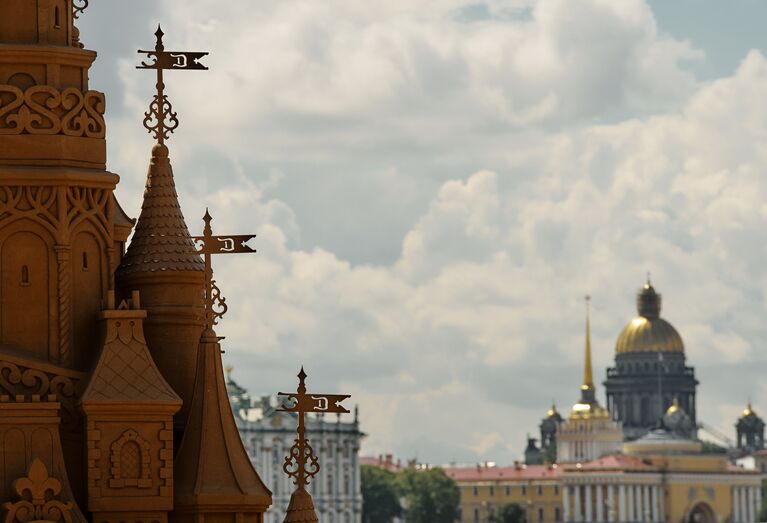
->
(80, 0, 767, 463)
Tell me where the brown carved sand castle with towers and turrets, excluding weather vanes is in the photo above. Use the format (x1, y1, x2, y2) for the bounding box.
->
(0, 0, 271, 523)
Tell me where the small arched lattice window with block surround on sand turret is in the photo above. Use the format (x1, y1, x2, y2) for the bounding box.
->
(109, 429, 152, 488)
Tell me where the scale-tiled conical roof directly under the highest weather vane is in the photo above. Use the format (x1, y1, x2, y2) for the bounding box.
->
(118, 145, 205, 275)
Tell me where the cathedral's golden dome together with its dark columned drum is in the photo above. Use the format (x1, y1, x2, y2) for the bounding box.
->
(605, 279, 698, 439)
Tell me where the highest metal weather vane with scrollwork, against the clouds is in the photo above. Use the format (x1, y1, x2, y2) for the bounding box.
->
(135, 26, 208, 145)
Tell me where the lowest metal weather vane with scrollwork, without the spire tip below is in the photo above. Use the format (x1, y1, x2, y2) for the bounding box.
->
(277, 367, 351, 504)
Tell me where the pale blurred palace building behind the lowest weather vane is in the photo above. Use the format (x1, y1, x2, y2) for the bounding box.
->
(227, 367, 365, 523)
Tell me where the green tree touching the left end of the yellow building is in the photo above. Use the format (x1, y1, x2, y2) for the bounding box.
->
(398, 468, 460, 523)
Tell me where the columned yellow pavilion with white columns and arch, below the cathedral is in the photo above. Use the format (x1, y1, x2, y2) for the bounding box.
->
(562, 429, 762, 523)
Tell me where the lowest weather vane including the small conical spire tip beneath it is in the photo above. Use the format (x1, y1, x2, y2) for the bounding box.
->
(277, 367, 351, 523)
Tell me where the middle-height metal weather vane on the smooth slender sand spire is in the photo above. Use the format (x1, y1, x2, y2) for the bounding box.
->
(192, 209, 256, 330)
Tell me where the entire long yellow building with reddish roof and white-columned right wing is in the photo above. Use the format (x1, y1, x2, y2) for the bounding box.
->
(446, 438, 763, 523)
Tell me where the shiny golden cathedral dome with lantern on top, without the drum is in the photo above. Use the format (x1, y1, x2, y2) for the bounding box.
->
(615, 281, 684, 354)
